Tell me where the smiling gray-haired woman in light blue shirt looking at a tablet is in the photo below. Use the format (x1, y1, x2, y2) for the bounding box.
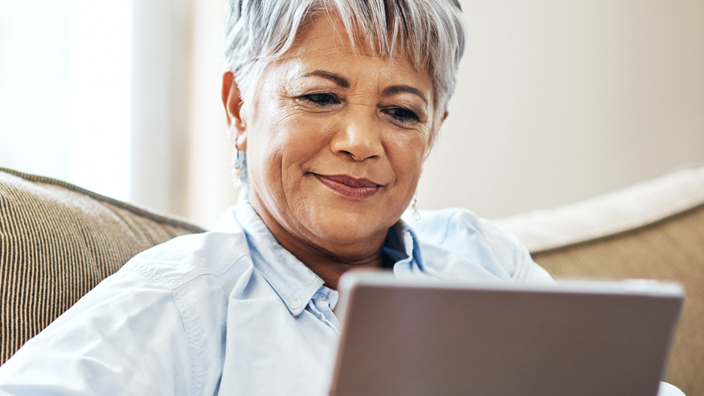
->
(0, 0, 684, 395)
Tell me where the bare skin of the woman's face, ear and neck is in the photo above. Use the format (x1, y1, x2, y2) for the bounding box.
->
(222, 15, 447, 289)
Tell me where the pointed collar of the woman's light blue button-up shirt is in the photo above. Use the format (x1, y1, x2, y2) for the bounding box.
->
(216, 186, 424, 316)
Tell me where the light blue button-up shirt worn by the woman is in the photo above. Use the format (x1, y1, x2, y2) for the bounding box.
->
(0, 198, 680, 395)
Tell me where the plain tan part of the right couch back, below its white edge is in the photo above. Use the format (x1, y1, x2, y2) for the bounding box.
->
(533, 206, 704, 395)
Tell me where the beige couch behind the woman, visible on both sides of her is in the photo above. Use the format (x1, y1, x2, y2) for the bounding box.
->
(0, 167, 704, 396)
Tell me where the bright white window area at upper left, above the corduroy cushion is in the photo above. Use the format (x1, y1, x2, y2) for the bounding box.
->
(0, 0, 132, 199)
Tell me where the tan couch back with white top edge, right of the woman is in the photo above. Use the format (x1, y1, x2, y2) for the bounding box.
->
(497, 167, 704, 395)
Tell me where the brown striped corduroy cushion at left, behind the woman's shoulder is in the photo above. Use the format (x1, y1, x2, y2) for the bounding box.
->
(0, 168, 204, 364)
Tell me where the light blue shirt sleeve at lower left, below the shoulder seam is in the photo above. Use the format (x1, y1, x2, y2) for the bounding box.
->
(0, 271, 191, 395)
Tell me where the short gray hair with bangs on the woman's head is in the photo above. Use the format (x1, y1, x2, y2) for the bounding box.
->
(224, 0, 465, 183)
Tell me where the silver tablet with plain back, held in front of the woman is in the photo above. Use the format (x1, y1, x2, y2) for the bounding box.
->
(331, 272, 683, 396)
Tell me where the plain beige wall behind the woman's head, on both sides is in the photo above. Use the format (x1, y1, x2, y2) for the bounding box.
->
(178, 0, 704, 227)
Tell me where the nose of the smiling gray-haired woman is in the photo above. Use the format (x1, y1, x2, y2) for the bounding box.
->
(330, 112, 384, 162)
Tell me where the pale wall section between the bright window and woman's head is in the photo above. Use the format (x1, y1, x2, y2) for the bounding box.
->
(131, 0, 237, 228)
